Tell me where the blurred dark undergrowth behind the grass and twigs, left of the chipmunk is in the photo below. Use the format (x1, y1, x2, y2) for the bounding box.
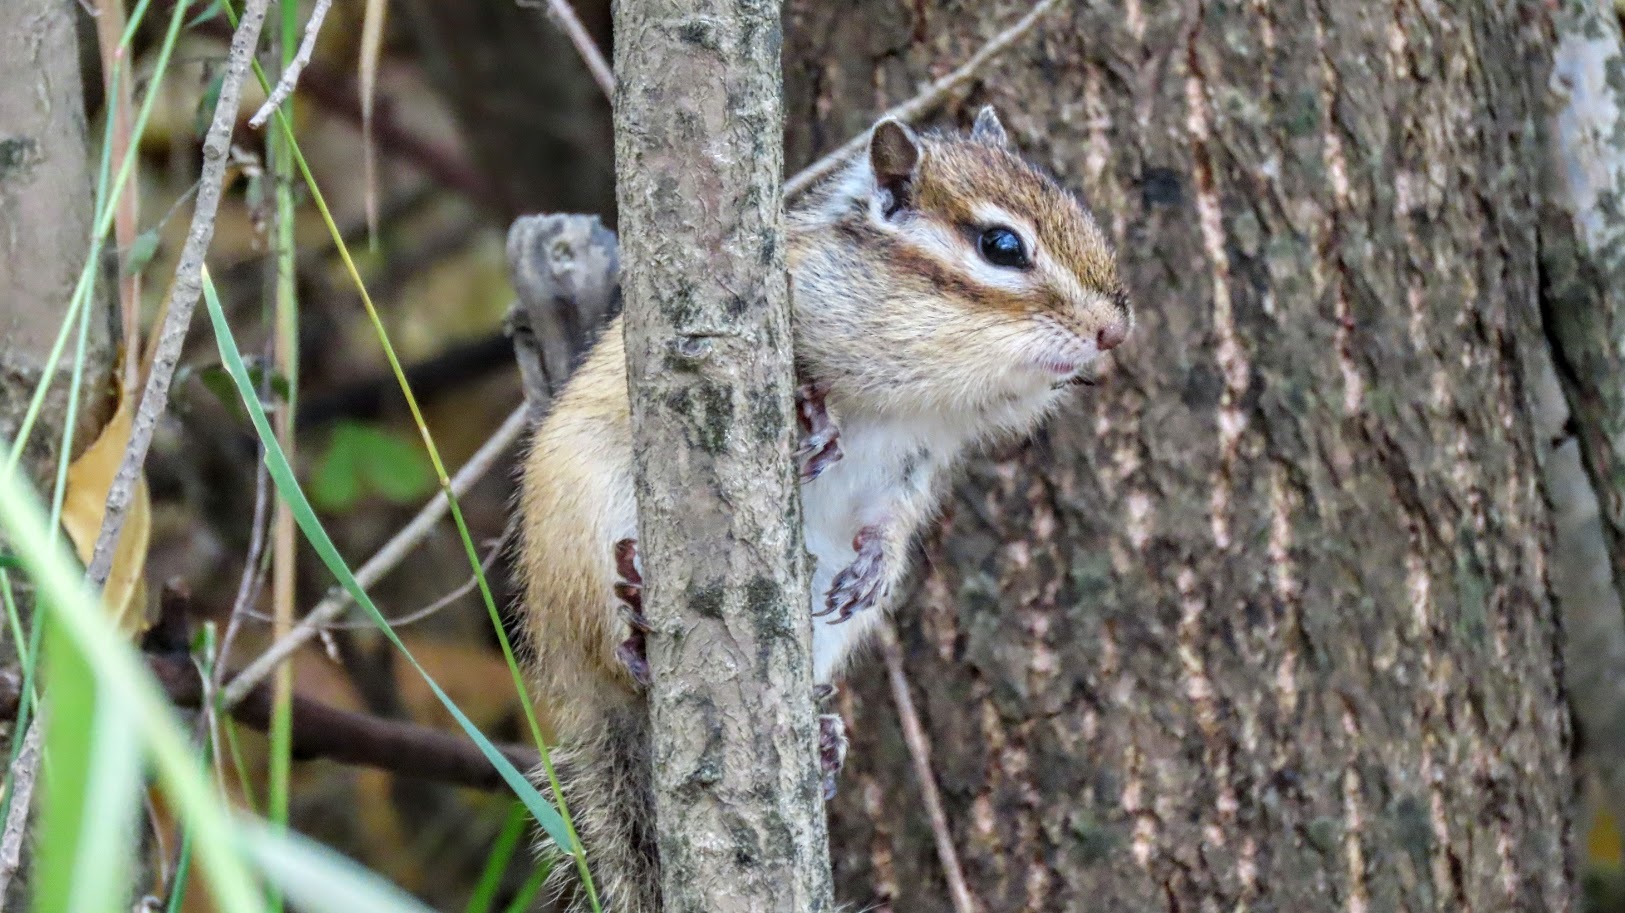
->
(80, 0, 614, 911)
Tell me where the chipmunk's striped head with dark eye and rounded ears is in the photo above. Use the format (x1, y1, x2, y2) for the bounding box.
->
(791, 107, 1133, 408)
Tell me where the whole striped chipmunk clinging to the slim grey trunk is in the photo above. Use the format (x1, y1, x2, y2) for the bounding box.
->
(520, 107, 1133, 913)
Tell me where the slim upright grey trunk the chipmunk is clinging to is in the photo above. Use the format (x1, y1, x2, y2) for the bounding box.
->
(614, 0, 830, 913)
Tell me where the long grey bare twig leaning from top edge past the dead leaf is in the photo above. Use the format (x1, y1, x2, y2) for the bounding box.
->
(86, 0, 267, 590)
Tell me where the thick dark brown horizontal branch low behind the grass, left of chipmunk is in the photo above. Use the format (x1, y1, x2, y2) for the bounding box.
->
(0, 655, 538, 789)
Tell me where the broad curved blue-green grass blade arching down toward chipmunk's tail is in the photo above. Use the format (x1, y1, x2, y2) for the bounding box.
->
(203, 268, 579, 848)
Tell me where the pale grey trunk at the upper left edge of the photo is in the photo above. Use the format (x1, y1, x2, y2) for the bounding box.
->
(0, 0, 112, 482)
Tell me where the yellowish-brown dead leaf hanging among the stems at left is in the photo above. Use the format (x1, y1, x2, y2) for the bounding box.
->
(62, 385, 153, 637)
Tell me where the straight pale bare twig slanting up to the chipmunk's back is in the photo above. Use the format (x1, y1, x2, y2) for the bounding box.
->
(221, 406, 527, 708)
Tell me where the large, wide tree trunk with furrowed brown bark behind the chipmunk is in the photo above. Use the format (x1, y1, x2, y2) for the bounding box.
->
(787, 0, 1573, 913)
